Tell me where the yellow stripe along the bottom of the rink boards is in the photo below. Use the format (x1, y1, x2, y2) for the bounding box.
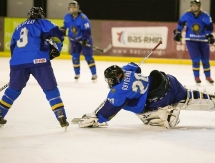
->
(0, 52, 215, 66)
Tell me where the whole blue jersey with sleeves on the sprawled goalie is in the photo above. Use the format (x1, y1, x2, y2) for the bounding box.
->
(97, 65, 150, 123)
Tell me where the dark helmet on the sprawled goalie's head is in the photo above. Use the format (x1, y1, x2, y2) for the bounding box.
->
(104, 65, 124, 88)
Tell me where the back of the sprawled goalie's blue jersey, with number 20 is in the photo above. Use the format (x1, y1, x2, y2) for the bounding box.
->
(108, 71, 149, 113)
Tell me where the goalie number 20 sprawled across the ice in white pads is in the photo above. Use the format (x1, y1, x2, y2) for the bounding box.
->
(79, 63, 215, 128)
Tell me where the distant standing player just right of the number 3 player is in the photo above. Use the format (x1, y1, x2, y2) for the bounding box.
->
(61, 1, 97, 82)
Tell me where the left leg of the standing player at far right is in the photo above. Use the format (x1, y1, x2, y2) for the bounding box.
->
(186, 41, 201, 83)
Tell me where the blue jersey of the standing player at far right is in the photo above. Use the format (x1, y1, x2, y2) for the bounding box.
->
(177, 11, 213, 40)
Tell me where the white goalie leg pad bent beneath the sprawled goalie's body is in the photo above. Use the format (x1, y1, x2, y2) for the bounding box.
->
(137, 105, 180, 129)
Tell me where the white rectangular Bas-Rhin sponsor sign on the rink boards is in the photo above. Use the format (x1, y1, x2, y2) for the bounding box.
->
(111, 26, 168, 49)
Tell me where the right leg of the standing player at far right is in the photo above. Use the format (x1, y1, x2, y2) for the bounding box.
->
(201, 42, 214, 83)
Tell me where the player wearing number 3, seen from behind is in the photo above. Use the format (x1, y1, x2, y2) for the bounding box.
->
(0, 7, 69, 131)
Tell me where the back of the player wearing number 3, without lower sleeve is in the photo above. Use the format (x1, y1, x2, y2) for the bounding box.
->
(10, 19, 55, 66)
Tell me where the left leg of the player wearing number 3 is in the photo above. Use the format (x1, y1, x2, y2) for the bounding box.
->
(0, 69, 30, 124)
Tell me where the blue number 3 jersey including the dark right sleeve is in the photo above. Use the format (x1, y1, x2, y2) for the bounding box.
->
(10, 18, 64, 68)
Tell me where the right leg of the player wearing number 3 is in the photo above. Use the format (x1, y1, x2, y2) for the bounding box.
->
(31, 65, 69, 127)
